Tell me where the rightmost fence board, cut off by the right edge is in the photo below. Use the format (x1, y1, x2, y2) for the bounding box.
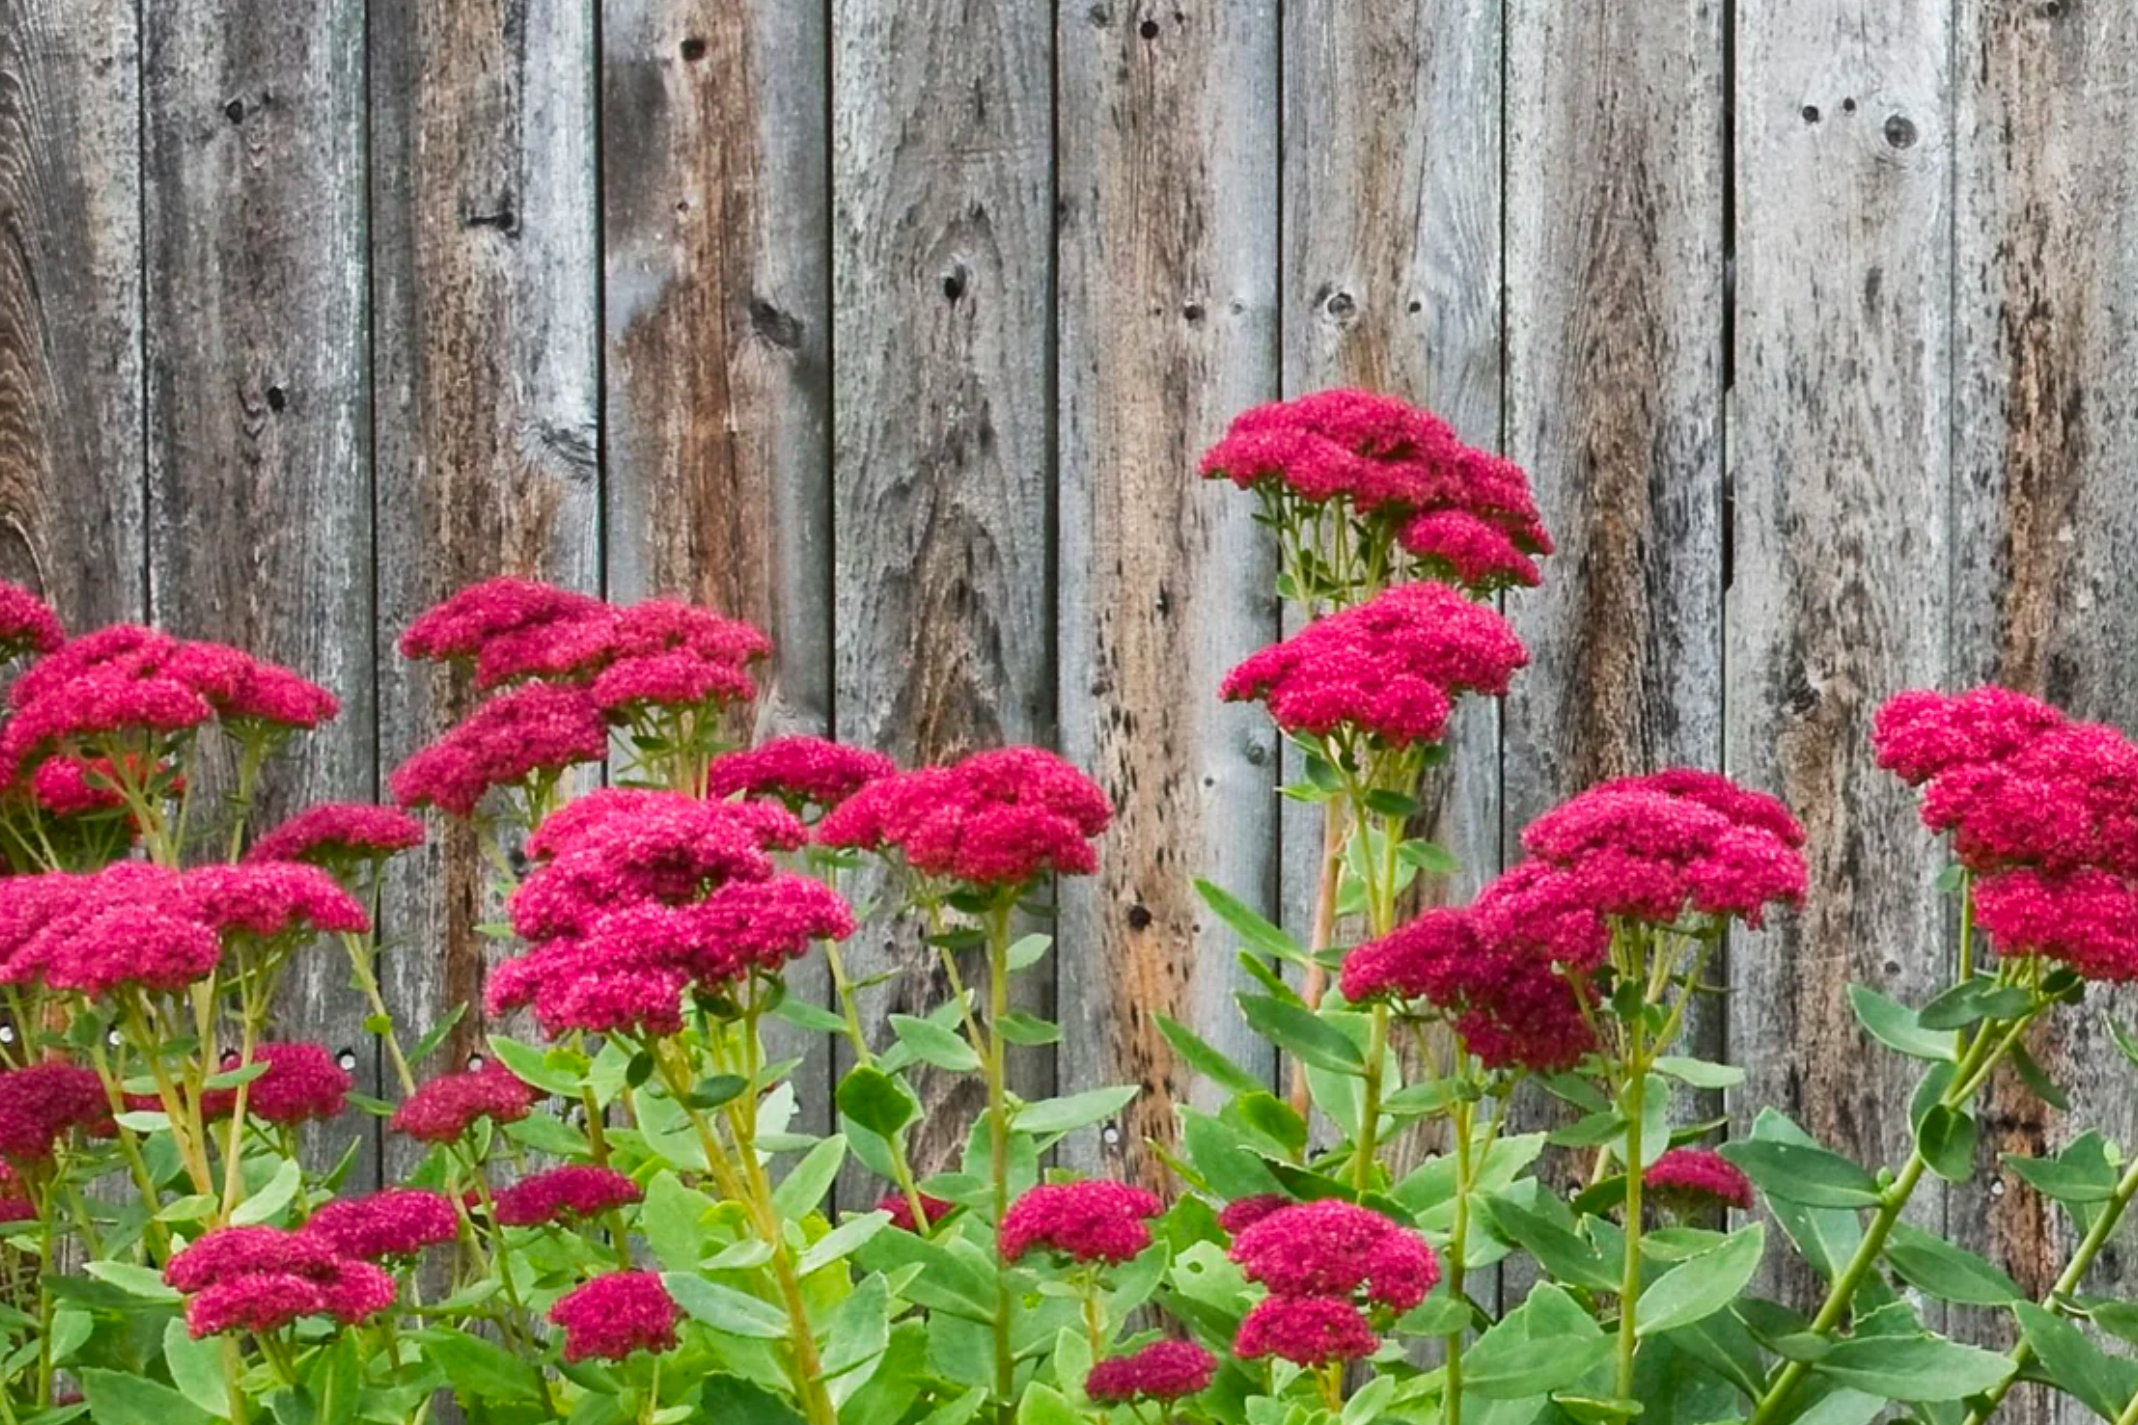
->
(1950, 0, 2138, 1423)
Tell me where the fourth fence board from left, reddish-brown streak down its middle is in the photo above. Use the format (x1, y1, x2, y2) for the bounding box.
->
(601, 0, 832, 1132)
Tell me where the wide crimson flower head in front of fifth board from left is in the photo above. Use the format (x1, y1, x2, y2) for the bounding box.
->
(817, 748, 1114, 887)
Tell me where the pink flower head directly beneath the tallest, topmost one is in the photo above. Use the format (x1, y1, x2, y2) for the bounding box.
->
(1219, 583, 1529, 748)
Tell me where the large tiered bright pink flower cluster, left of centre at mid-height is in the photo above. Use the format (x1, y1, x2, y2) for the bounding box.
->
(487, 790, 853, 1036)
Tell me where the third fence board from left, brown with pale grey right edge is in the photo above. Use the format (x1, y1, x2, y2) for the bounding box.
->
(372, 0, 601, 1136)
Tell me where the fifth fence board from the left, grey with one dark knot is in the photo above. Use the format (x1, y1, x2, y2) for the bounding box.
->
(832, 0, 1054, 1171)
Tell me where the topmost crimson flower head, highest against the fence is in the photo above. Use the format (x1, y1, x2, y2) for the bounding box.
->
(1202, 391, 1552, 592)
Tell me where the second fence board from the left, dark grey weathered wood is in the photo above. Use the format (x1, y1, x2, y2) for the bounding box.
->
(141, 2, 376, 1181)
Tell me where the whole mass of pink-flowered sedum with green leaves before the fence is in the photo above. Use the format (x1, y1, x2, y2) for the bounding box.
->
(0, 391, 2138, 1425)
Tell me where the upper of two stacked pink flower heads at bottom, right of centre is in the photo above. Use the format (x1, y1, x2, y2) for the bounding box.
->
(1231, 1199, 1441, 1312)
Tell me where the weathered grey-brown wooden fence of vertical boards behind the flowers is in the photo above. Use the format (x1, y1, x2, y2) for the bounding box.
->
(0, 0, 2138, 1367)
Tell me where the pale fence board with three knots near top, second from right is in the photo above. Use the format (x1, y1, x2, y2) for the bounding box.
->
(1728, 0, 1952, 1288)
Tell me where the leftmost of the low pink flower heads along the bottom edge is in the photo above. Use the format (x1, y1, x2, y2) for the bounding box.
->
(162, 1226, 400, 1337)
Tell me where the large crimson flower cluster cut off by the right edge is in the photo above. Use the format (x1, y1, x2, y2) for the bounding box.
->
(1871, 688, 2138, 981)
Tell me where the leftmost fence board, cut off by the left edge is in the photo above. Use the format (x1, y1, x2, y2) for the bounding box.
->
(0, 0, 148, 630)
